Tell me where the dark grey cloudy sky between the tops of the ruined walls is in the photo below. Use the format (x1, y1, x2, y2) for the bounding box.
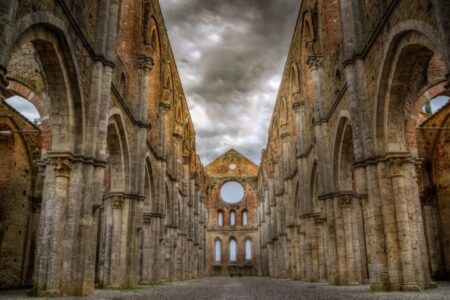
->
(160, 0, 301, 164)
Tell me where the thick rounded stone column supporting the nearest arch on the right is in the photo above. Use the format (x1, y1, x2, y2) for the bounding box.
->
(379, 156, 432, 290)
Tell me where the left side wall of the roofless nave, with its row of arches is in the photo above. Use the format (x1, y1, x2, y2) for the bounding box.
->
(0, 0, 207, 296)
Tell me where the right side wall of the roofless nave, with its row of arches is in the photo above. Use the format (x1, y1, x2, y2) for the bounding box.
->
(258, 0, 449, 290)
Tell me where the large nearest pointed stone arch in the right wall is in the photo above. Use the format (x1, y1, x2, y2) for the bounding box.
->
(373, 22, 445, 155)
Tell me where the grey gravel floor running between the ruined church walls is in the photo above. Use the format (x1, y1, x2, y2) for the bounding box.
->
(0, 277, 450, 300)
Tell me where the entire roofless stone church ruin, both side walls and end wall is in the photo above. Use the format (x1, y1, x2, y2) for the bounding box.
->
(0, 0, 450, 296)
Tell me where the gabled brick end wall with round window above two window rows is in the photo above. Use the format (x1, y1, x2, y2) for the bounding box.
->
(205, 149, 261, 276)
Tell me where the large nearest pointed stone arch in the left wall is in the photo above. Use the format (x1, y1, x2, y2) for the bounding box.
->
(5, 12, 85, 153)
